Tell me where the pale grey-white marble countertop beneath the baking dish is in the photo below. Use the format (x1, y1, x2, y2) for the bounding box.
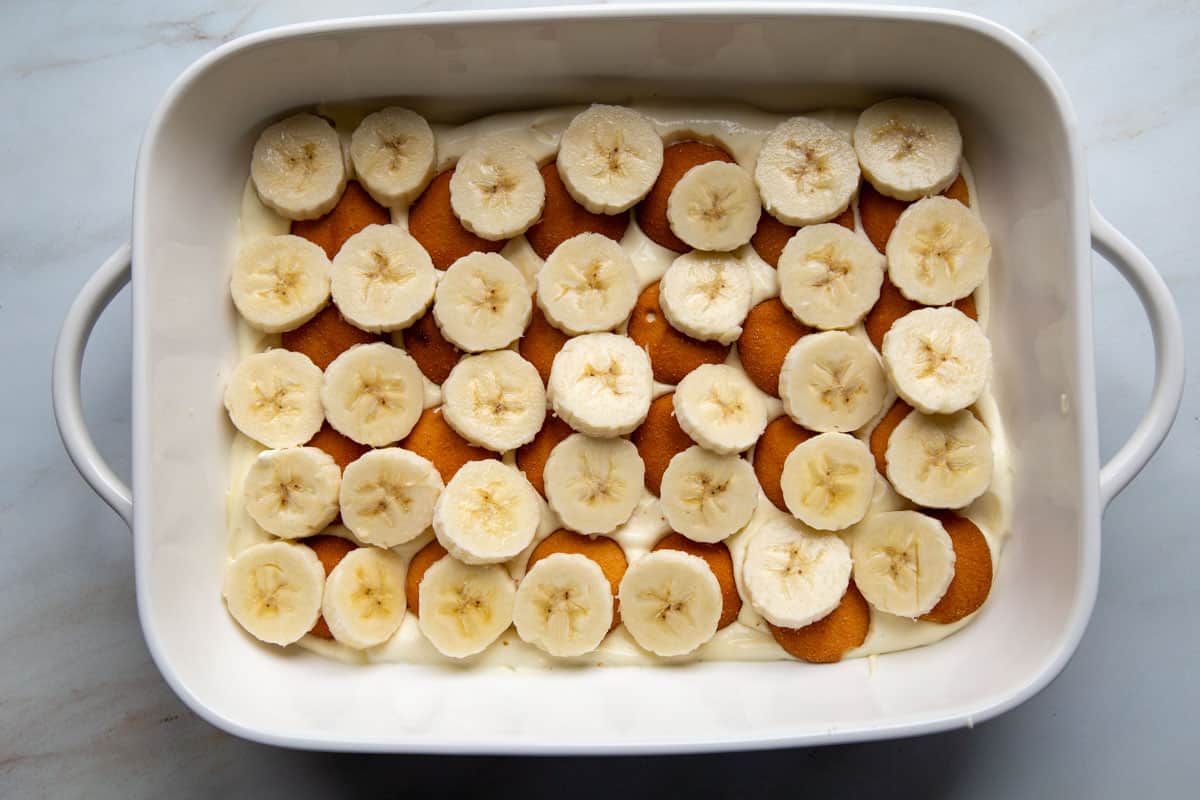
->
(0, 0, 1200, 798)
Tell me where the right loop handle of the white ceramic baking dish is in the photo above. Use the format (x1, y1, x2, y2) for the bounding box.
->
(1092, 205, 1183, 506)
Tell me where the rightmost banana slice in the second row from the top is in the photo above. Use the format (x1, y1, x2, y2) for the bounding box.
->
(887, 197, 991, 306)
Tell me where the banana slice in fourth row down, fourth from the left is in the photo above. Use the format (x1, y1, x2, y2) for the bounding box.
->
(542, 433, 646, 534)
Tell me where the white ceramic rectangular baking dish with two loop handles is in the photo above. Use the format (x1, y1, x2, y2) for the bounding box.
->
(54, 4, 1183, 753)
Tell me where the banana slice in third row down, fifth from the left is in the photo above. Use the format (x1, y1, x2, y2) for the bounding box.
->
(674, 363, 767, 453)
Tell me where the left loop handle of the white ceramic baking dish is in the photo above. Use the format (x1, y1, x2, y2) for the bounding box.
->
(50, 243, 133, 528)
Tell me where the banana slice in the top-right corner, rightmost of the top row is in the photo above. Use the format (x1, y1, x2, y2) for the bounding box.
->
(854, 97, 962, 200)
